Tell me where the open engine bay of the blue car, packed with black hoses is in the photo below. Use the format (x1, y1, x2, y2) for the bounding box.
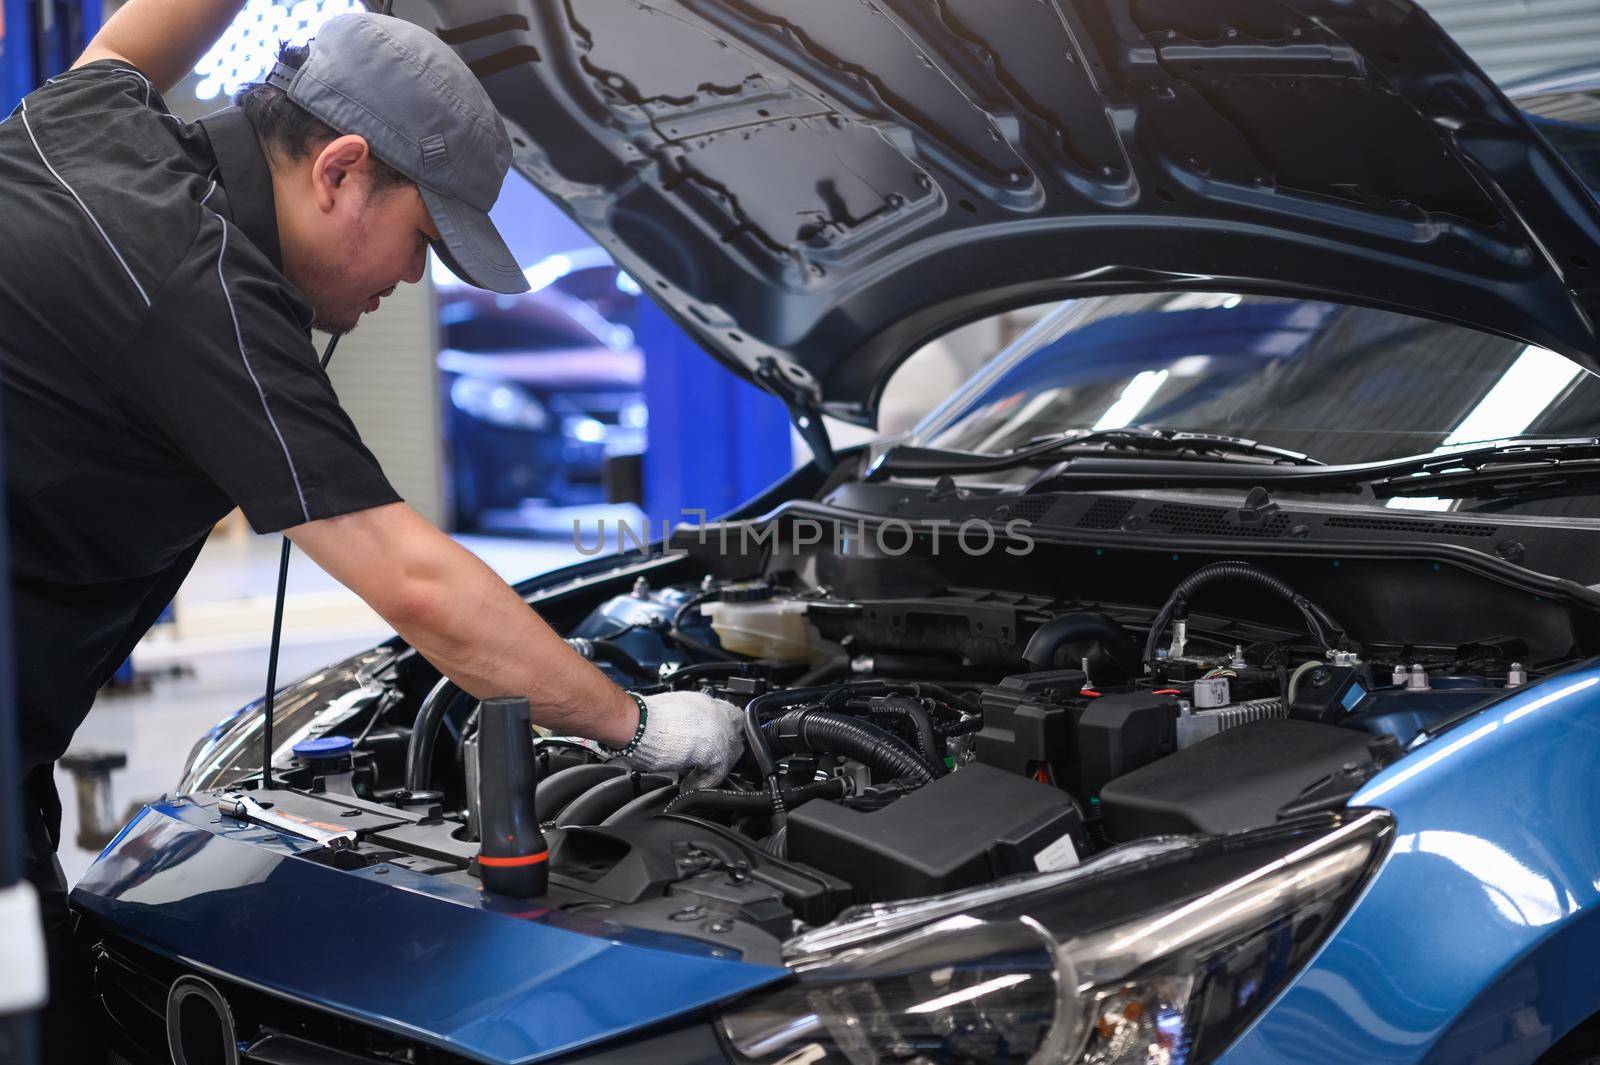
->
(212, 486, 1594, 963)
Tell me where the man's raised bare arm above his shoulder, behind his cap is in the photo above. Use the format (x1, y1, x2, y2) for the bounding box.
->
(72, 0, 245, 93)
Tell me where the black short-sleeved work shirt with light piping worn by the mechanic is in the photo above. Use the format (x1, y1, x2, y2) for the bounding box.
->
(0, 61, 398, 772)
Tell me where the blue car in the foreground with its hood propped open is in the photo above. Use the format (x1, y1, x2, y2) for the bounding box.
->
(72, 0, 1600, 1065)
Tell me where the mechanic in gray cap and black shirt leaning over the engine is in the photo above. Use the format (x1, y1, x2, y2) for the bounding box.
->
(0, 0, 741, 1062)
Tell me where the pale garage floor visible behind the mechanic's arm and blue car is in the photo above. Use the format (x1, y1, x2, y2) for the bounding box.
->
(56, 533, 581, 883)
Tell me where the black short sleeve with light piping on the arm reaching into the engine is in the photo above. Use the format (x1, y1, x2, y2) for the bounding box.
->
(122, 211, 400, 533)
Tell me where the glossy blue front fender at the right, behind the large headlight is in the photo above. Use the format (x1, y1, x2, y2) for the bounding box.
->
(1218, 664, 1600, 1065)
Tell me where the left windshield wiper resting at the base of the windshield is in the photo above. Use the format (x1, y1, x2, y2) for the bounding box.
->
(866, 427, 1322, 481)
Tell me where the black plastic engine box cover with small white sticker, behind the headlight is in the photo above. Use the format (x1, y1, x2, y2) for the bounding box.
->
(789, 763, 1085, 900)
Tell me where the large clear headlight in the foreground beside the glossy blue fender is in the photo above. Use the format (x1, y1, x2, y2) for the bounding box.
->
(720, 811, 1392, 1065)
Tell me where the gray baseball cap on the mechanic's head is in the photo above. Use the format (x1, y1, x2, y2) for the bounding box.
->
(267, 14, 528, 293)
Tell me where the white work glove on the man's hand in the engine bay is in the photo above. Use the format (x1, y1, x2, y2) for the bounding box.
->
(622, 691, 744, 792)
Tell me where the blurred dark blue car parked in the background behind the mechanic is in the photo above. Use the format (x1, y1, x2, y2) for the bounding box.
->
(438, 260, 648, 533)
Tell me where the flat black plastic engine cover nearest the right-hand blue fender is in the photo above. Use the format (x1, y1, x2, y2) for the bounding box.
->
(1099, 720, 1371, 843)
